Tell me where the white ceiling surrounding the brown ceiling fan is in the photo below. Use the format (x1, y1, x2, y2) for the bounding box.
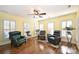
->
(0, 5, 79, 19)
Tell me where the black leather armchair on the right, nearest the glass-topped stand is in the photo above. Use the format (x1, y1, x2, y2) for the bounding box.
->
(47, 30, 61, 45)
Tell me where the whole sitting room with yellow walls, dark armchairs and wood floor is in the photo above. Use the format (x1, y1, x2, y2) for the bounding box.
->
(0, 5, 79, 54)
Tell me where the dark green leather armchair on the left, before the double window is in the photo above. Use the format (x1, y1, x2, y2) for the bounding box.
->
(9, 31, 26, 47)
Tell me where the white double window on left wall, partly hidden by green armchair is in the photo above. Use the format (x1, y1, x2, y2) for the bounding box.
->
(3, 20, 15, 39)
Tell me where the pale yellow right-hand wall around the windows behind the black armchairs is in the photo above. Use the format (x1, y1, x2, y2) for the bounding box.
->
(38, 12, 77, 43)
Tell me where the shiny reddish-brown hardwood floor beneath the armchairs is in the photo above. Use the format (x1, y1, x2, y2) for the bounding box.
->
(0, 38, 78, 54)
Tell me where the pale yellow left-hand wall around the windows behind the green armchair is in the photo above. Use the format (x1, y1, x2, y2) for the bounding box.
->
(0, 12, 34, 42)
